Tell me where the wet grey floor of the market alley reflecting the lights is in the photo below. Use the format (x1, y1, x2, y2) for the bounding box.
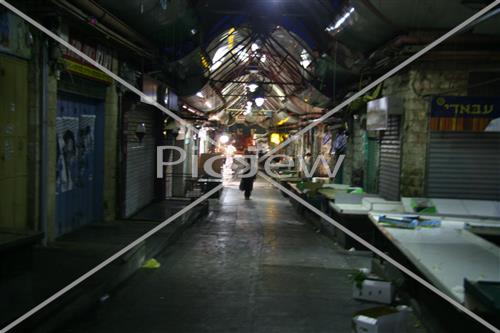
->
(63, 182, 374, 333)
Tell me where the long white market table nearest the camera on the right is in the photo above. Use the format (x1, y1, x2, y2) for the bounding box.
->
(369, 213, 500, 303)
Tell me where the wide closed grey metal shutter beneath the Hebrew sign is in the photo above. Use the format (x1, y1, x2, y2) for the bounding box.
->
(427, 132, 500, 200)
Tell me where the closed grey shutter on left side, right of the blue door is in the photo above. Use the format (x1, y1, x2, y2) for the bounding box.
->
(124, 104, 156, 217)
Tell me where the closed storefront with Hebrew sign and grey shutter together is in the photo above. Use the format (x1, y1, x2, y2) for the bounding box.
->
(426, 96, 500, 200)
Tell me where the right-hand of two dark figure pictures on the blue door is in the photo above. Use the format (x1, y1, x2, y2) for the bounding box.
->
(78, 115, 96, 185)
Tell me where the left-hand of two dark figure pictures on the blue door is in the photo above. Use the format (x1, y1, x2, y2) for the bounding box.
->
(56, 117, 79, 194)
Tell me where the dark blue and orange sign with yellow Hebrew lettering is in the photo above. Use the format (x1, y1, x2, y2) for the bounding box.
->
(430, 96, 500, 132)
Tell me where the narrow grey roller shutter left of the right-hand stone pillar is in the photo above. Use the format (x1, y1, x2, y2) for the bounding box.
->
(379, 116, 401, 200)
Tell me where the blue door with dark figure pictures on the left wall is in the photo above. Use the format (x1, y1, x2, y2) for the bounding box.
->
(56, 93, 104, 236)
